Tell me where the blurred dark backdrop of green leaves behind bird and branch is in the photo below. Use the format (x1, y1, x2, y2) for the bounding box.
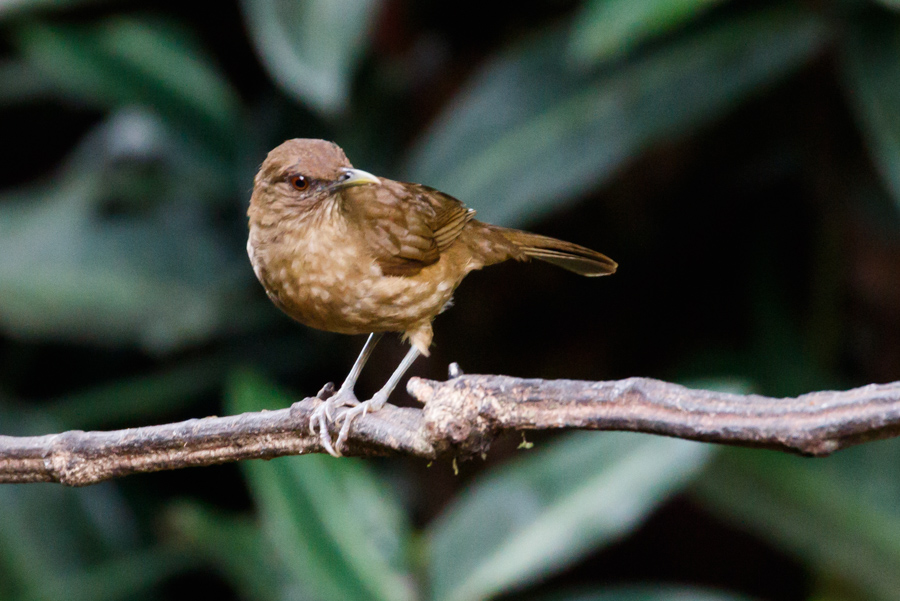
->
(0, 0, 900, 601)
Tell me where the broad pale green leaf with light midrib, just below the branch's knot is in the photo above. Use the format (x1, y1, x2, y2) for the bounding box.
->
(428, 432, 713, 601)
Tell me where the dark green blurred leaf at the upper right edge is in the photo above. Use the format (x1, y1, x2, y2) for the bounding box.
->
(842, 14, 900, 212)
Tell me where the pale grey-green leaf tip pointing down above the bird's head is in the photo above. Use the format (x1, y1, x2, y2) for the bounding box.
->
(241, 0, 380, 115)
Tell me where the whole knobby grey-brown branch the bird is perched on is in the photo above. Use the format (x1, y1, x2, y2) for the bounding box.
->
(0, 375, 900, 486)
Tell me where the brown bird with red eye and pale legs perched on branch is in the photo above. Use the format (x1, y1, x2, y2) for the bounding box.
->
(247, 139, 616, 456)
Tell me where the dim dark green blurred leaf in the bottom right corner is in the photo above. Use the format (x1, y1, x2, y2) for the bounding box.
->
(696, 439, 900, 601)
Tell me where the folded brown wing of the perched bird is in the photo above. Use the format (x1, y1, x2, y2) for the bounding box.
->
(344, 182, 475, 276)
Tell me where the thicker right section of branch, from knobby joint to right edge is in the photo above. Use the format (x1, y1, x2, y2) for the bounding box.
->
(409, 376, 900, 456)
